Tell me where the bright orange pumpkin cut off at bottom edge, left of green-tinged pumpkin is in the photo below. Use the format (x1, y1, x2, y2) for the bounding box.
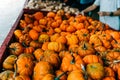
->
(67, 70, 85, 80)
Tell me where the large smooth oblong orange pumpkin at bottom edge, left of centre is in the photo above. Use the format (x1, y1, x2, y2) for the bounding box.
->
(33, 61, 53, 80)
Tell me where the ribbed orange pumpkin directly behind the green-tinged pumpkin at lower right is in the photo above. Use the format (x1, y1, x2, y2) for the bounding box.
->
(83, 55, 103, 64)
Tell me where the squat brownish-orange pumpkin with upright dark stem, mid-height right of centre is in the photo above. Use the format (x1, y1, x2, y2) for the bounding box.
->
(78, 41, 95, 57)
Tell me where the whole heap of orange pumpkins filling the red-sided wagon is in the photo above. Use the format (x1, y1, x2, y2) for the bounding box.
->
(0, 10, 120, 80)
